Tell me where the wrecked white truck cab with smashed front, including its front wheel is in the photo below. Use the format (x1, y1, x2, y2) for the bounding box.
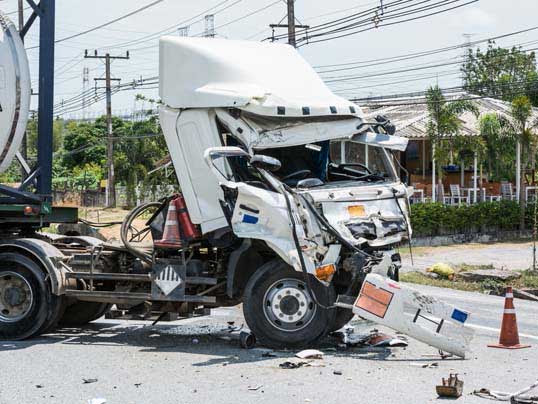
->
(160, 37, 411, 345)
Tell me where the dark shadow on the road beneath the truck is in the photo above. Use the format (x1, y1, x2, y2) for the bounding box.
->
(0, 318, 460, 367)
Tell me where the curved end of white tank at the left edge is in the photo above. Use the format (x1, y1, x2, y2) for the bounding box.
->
(0, 12, 30, 172)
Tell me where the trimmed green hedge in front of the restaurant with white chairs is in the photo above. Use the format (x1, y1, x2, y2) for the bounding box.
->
(411, 201, 534, 237)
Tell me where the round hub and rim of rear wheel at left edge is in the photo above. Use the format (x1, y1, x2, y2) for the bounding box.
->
(0, 271, 34, 323)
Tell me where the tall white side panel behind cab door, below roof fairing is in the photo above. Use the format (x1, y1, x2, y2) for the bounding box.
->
(160, 107, 228, 233)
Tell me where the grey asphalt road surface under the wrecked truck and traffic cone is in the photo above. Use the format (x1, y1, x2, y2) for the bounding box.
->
(0, 286, 538, 404)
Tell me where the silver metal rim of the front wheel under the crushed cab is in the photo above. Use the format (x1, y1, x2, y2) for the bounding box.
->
(263, 278, 317, 332)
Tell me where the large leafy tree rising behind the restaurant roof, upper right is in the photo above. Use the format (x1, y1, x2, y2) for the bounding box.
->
(461, 41, 538, 106)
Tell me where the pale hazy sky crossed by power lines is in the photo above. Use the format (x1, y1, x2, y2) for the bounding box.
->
(0, 0, 538, 119)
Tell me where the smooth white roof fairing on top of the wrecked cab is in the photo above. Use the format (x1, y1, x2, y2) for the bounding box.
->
(159, 36, 362, 118)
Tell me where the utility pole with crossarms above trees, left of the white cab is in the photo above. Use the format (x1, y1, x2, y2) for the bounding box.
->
(84, 50, 129, 208)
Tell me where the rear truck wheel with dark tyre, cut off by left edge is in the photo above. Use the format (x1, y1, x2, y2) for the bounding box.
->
(0, 253, 52, 340)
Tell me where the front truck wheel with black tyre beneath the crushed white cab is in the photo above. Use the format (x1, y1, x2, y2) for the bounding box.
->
(243, 259, 335, 348)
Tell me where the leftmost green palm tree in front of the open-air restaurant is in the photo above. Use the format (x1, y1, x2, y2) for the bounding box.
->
(426, 86, 478, 194)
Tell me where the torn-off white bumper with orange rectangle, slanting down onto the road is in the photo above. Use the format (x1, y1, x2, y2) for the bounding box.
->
(337, 274, 474, 358)
